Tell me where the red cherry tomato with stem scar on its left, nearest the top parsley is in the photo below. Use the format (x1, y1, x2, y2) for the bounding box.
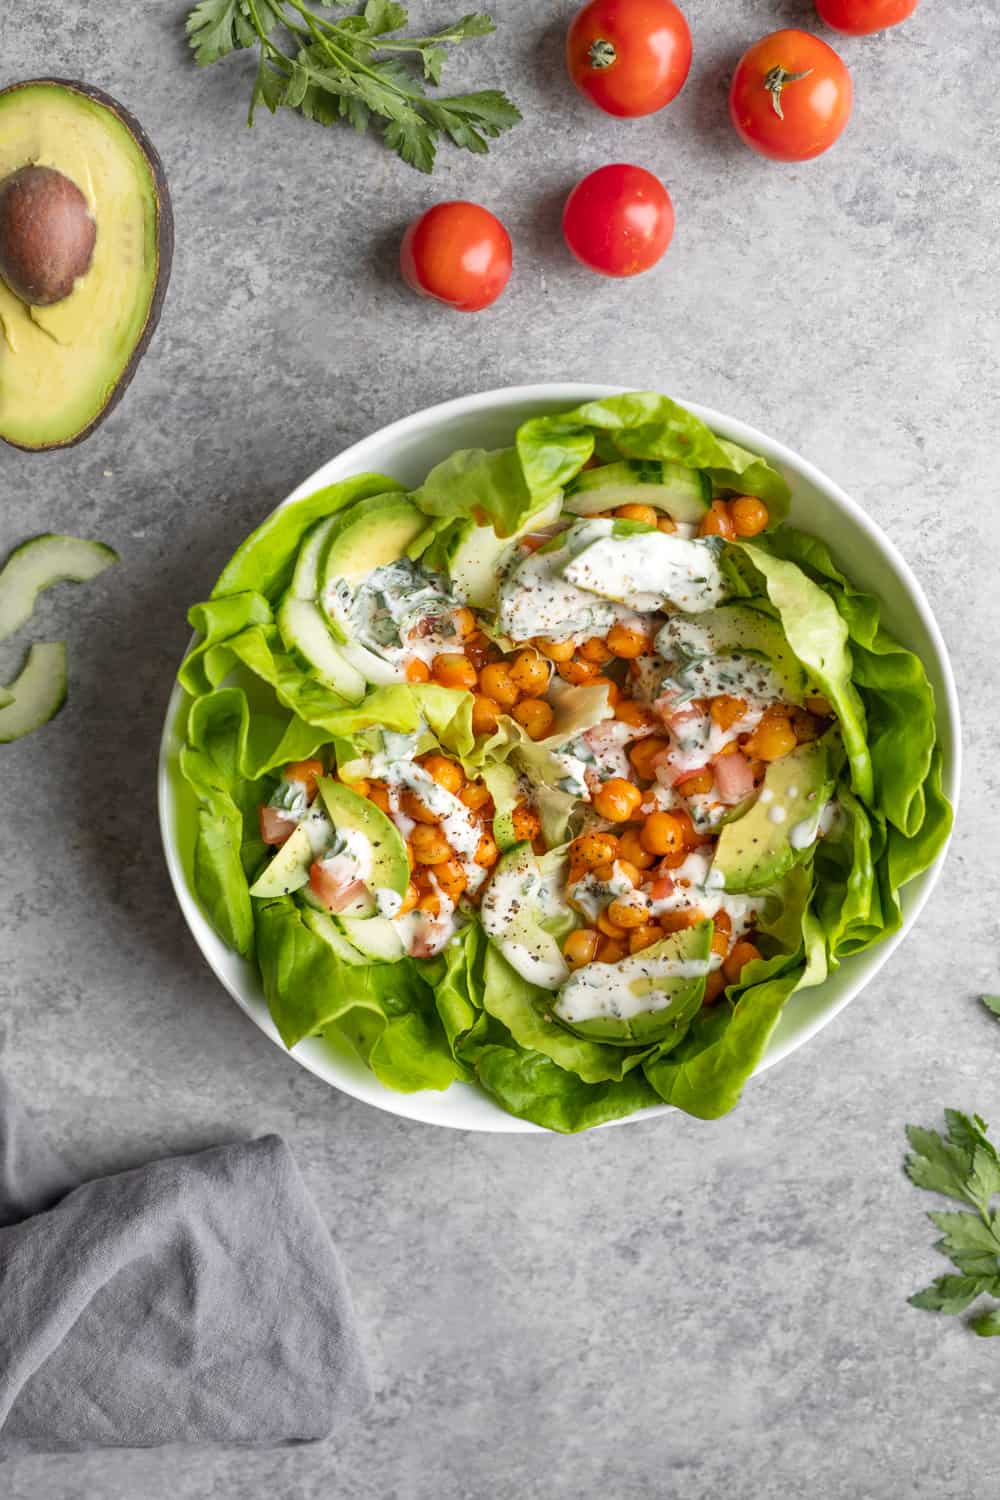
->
(567, 0, 691, 116)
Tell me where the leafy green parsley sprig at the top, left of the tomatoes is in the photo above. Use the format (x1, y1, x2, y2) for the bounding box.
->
(187, 0, 520, 173)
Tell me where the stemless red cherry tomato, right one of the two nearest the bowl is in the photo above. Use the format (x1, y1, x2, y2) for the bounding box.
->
(562, 162, 673, 276)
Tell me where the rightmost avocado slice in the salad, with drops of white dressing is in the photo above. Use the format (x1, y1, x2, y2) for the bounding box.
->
(709, 731, 835, 891)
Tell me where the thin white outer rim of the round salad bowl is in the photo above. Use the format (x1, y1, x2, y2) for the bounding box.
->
(157, 381, 963, 1136)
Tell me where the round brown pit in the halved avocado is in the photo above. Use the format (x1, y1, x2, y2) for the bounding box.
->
(0, 165, 97, 308)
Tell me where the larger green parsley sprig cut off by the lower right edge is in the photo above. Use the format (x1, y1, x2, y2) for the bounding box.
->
(906, 1110, 1000, 1338)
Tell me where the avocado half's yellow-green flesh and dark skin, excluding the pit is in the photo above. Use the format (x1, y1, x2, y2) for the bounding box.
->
(0, 78, 174, 452)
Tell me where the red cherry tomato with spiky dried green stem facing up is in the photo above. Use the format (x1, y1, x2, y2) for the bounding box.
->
(729, 30, 855, 162)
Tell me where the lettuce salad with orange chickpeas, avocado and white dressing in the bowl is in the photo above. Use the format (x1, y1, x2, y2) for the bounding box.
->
(170, 393, 951, 1131)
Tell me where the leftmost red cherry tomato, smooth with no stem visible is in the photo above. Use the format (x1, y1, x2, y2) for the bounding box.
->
(399, 201, 513, 312)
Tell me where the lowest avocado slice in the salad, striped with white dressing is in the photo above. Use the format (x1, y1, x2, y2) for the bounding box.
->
(552, 923, 712, 1047)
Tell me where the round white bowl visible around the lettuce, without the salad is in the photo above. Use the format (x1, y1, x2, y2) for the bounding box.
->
(159, 384, 961, 1131)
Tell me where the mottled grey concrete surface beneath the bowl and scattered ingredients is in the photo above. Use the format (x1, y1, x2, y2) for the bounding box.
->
(0, 0, 1000, 1500)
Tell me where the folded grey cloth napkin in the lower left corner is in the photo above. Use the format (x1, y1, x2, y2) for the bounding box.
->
(0, 1079, 369, 1452)
